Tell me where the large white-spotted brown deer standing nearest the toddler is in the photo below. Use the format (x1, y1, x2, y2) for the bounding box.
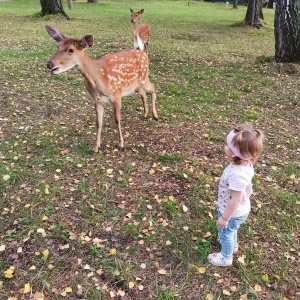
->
(45, 25, 158, 152)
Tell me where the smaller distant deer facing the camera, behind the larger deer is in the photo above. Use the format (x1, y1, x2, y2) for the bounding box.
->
(129, 8, 151, 54)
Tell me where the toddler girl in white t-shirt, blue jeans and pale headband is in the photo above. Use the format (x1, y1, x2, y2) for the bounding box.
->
(208, 124, 263, 267)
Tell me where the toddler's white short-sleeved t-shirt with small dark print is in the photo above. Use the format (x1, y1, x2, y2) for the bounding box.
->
(218, 161, 254, 217)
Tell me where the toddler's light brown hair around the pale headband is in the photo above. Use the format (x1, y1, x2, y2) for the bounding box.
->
(232, 123, 264, 164)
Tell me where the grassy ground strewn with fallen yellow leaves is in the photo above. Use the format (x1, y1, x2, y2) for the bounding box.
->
(0, 0, 300, 300)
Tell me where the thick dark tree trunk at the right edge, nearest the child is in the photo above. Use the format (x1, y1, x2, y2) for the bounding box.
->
(274, 0, 300, 63)
